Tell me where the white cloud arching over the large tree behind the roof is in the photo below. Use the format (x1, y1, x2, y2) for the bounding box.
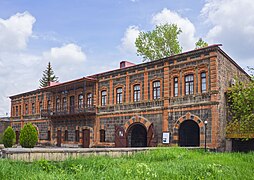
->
(152, 8, 198, 51)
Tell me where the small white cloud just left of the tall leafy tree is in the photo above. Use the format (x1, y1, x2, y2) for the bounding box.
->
(120, 26, 140, 54)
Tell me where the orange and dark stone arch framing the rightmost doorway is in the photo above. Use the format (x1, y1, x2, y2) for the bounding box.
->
(173, 112, 205, 145)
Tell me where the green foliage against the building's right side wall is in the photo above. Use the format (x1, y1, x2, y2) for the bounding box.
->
(226, 69, 254, 139)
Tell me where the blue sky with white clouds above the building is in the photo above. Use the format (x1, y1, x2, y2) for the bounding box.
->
(0, 0, 254, 117)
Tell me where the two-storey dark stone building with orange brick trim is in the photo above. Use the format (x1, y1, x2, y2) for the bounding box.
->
(10, 45, 249, 150)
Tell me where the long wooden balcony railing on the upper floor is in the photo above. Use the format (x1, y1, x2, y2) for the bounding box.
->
(41, 106, 96, 118)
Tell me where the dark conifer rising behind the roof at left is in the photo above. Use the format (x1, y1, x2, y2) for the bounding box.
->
(40, 62, 58, 88)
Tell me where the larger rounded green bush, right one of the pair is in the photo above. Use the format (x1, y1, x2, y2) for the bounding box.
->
(19, 123, 38, 148)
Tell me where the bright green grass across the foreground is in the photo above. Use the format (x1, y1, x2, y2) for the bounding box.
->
(0, 148, 254, 180)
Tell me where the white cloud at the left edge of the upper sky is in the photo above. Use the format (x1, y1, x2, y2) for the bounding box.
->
(0, 12, 35, 52)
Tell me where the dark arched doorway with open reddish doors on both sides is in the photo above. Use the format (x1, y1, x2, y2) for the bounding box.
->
(128, 123, 147, 147)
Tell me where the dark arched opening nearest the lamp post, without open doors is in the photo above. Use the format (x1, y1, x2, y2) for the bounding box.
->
(178, 120, 200, 147)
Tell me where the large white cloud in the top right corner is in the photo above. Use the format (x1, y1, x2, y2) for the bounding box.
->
(201, 0, 254, 66)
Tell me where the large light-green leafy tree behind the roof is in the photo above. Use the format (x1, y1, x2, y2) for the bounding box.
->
(135, 24, 182, 61)
